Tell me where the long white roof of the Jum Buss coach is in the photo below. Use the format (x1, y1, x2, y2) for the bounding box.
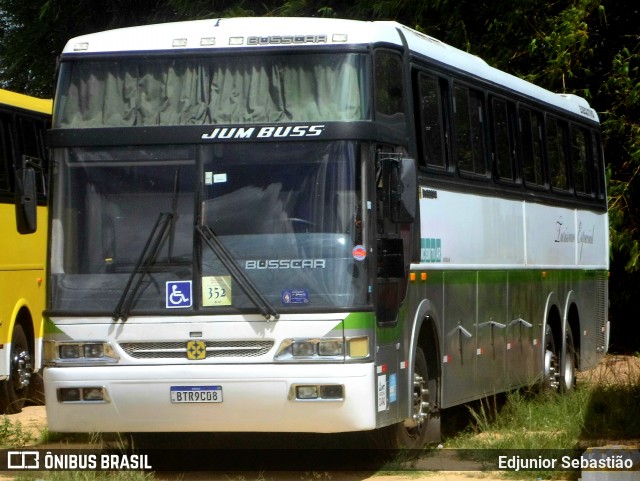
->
(63, 17, 598, 122)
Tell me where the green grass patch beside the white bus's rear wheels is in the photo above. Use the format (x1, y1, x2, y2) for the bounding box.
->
(445, 352, 640, 479)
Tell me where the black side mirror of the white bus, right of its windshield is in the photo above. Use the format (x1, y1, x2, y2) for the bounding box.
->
(389, 158, 418, 223)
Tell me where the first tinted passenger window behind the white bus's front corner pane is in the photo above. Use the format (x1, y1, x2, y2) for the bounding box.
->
(418, 73, 446, 169)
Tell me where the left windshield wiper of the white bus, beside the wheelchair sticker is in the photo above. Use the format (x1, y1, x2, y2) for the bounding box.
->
(113, 212, 173, 322)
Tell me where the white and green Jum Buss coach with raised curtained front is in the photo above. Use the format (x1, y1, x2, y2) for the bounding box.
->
(44, 18, 608, 447)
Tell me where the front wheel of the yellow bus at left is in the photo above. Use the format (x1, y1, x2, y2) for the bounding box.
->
(0, 324, 33, 414)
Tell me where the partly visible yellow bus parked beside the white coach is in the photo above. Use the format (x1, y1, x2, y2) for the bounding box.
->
(0, 89, 52, 414)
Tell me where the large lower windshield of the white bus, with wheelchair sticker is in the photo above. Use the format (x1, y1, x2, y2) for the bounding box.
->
(50, 141, 368, 318)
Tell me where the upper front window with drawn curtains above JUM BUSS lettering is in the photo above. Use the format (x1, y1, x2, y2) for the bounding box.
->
(54, 53, 370, 128)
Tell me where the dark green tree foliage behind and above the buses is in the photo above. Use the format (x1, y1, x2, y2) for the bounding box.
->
(0, 0, 640, 351)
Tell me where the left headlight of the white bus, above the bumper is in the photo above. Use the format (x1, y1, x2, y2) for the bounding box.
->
(44, 341, 119, 366)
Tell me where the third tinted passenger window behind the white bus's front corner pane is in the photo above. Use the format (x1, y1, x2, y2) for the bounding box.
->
(491, 98, 516, 182)
